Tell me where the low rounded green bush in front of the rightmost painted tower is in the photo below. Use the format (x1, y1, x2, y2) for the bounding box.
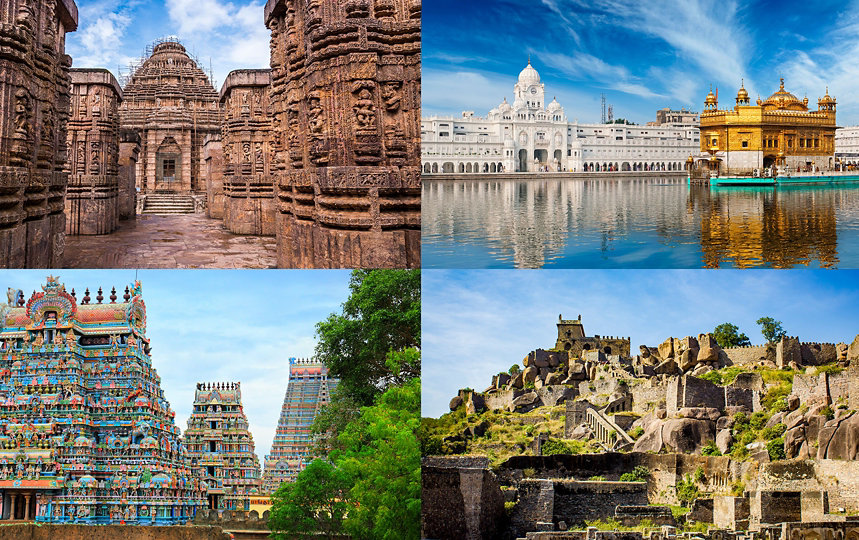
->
(268, 459, 351, 540)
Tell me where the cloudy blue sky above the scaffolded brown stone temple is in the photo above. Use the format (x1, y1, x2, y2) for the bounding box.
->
(66, 0, 270, 90)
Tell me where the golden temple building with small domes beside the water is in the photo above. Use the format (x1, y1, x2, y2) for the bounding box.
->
(696, 79, 836, 174)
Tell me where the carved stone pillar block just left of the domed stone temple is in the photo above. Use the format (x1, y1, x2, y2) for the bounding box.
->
(66, 69, 122, 234)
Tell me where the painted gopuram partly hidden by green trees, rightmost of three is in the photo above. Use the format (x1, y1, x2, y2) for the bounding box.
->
(262, 358, 338, 494)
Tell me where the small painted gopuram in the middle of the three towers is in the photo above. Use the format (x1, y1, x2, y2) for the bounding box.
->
(185, 383, 260, 511)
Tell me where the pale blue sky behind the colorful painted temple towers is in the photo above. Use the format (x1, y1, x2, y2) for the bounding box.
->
(0, 270, 349, 466)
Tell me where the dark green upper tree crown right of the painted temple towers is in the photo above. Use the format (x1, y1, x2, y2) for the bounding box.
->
(316, 270, 421, 406)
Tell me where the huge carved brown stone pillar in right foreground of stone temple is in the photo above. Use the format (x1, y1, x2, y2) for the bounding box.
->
(265, 0, 421, 268)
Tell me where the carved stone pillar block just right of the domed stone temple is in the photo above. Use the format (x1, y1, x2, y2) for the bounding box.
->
(221, 69, 276, 236)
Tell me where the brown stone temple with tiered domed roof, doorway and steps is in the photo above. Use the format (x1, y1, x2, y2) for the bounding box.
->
(120, 41, 221, 193)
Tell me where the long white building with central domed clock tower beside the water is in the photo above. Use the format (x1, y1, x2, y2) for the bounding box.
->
(421, 61, 700, 174)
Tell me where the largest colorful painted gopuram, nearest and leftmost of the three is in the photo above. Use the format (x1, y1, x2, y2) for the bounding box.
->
(0, 277, 206, 524)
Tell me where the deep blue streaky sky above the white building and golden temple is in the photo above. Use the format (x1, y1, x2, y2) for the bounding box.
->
(422, 0, 859, 125)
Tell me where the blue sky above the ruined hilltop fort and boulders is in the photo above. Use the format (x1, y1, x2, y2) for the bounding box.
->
(421, 270, 859, 417)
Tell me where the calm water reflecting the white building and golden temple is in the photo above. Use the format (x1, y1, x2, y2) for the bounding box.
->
(422, 177, 859, 268)
